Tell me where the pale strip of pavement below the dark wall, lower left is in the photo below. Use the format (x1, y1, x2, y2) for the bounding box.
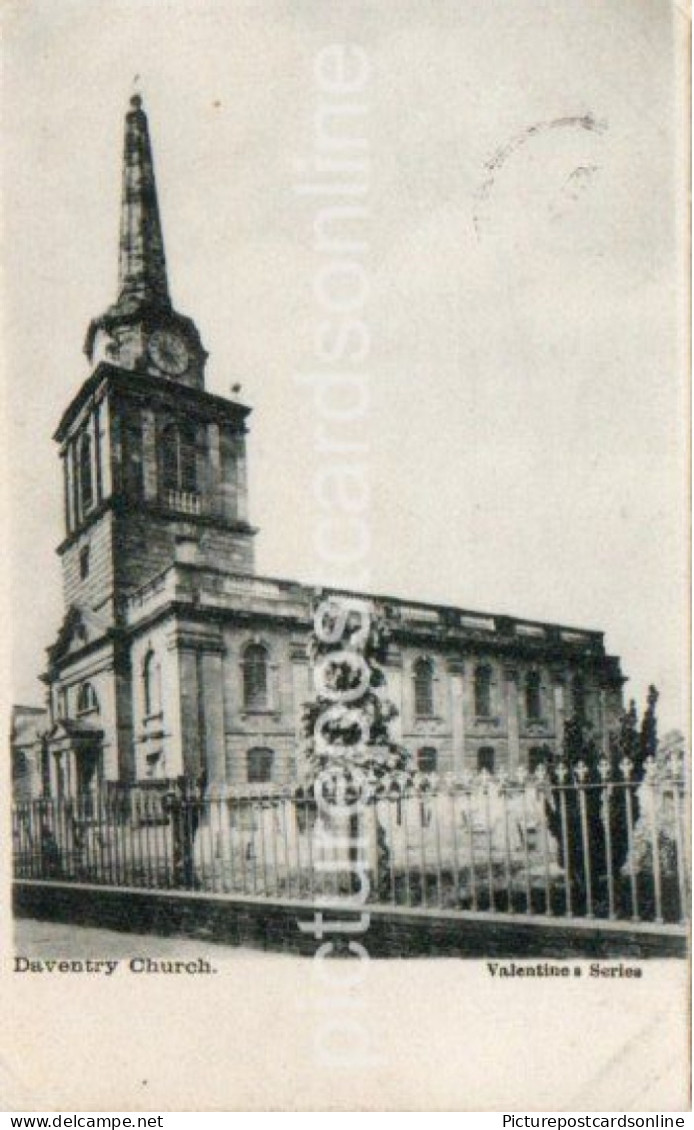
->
(15, 919, 288, 962)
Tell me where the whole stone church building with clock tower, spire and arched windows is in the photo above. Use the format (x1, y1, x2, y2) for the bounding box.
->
(37, 96, 624, 794)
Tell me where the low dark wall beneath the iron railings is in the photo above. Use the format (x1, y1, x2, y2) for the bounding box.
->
(14, 880, 687, 958)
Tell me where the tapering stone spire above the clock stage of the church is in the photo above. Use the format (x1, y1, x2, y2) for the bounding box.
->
(116, 94, 171, 312)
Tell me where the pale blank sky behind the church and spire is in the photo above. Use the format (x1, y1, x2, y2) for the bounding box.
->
(5, 0, 687, 730)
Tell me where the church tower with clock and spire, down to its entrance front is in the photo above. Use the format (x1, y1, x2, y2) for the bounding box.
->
(44, 95, 255, 791)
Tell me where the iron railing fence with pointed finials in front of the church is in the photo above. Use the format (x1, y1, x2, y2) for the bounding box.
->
(12, 763, 689, 923)
